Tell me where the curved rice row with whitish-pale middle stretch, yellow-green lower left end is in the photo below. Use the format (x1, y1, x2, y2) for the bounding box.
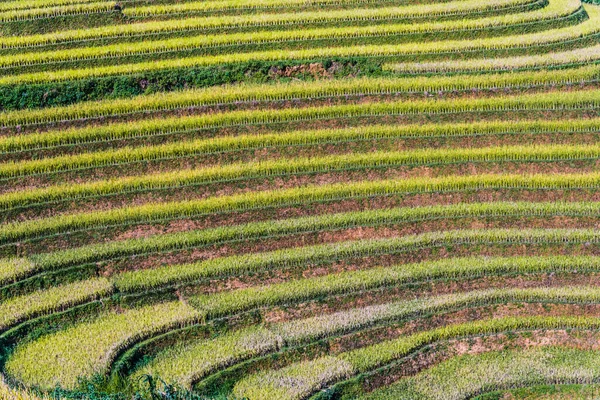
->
(135, 286, 600, 389)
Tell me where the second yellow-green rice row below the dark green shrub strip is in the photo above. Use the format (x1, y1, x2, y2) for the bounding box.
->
(9, 89, 600, 151)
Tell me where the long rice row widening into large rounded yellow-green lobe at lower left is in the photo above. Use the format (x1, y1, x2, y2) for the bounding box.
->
(6, 256, 598, 389)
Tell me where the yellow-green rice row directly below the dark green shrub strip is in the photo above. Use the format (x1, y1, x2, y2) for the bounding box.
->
(0, 65, 600, 130)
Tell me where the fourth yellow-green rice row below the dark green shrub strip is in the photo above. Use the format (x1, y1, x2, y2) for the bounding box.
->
(8, 145, 600, 209)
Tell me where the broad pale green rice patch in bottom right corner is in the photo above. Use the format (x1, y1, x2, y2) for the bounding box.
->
(360, 346, 600, 400)
